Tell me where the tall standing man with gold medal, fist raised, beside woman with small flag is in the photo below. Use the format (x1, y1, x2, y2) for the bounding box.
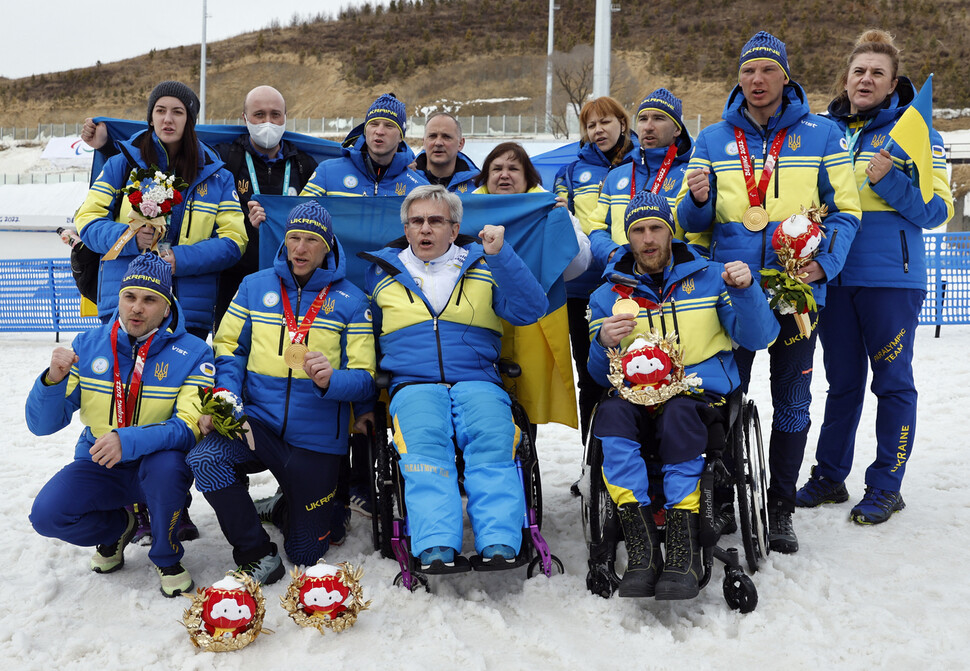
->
(677, 31, 862, 553)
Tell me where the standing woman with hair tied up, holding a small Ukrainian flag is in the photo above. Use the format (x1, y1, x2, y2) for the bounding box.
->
(795, 30, 953, 524)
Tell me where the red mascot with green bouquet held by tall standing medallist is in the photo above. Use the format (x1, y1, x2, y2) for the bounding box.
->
(761, 203, 828, 338)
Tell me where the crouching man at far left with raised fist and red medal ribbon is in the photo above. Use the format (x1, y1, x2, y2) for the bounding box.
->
(27, 253, 215, 597)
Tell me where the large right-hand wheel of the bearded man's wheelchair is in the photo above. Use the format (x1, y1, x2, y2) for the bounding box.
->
(734, 401, 768, 573)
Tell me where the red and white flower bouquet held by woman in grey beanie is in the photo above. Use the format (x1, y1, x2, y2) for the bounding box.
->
(104, 165, 189, 260)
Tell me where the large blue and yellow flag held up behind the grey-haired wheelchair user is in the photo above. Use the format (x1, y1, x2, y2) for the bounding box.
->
(259, 192, 579, 428)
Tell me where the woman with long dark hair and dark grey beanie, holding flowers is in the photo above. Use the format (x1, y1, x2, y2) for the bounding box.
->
(75, 81, 246, 340)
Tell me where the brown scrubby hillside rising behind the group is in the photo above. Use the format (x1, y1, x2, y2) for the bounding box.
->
(0, 0, 970, 130)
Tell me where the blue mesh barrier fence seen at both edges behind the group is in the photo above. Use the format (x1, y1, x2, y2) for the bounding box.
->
(0, 233, 970, 335)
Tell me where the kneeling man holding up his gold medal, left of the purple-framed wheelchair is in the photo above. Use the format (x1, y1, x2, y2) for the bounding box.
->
(188, 201, 375, 584)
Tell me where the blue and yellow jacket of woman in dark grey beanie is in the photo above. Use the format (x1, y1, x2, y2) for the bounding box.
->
(74, 130, 247, 328)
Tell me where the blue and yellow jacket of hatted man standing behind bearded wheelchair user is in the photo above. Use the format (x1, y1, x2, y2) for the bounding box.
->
(589, 131, 710, 268)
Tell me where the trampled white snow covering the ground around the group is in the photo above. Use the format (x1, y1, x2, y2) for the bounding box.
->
(0, 326, 970, 671)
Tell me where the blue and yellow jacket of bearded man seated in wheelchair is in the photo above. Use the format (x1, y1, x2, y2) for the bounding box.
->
(588, 240, 779, 394)
